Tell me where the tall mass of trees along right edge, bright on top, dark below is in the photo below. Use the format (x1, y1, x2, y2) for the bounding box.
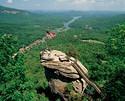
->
(104, 25, 125, 101)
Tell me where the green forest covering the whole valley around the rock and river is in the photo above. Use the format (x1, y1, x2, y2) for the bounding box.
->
(0, 6, 125, 101)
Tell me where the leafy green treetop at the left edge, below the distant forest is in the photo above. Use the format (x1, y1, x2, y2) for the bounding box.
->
(0, 34, 18, 66)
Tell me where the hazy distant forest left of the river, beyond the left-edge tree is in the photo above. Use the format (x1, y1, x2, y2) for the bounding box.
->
(0, 6, 71, 47)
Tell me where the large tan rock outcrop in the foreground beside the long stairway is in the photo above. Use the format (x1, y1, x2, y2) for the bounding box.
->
(40, 50, 88, 100)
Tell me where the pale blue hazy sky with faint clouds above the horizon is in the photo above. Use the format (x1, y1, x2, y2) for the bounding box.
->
(0, 0, 125, 11)
